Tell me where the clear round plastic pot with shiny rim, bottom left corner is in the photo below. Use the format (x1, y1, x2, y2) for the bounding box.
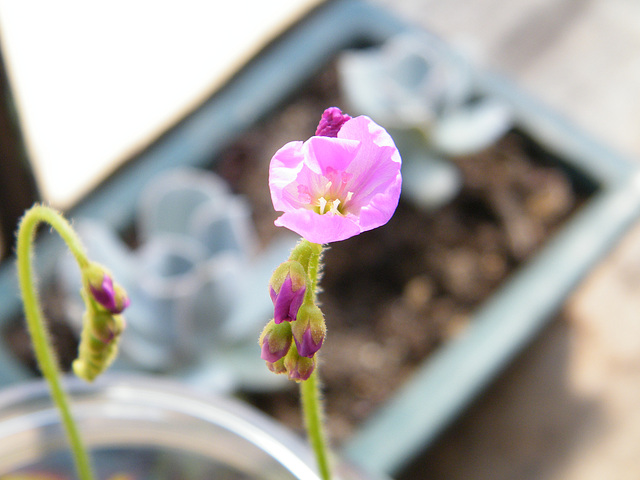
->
(0, 376, 380, 480)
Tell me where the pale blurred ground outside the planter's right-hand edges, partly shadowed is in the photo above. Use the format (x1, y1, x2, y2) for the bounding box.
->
(376, 0, 640, 480)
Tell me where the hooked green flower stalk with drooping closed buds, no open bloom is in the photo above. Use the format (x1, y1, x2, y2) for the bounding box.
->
(17, 205, 129, 480)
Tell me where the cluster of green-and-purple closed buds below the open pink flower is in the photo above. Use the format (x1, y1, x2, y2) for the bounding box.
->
(260, 240, 326, 382)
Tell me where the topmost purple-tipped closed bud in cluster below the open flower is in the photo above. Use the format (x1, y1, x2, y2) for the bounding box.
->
(269, 260, 307, 323)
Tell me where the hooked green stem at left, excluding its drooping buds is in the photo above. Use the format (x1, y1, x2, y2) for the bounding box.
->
(17, 205, 93, 480)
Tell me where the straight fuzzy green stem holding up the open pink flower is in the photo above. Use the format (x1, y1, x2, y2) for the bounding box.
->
(300, 240, 331, 480)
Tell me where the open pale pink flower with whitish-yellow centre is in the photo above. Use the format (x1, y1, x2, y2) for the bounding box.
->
(269, 111, 402, 244)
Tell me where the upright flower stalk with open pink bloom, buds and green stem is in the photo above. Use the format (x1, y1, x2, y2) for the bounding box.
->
(259, 107, 402, 480)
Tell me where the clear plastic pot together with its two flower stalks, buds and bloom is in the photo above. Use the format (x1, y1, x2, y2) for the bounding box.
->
(0, 107, 402, 480)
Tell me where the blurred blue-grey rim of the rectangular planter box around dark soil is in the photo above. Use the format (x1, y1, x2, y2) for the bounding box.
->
(0, 0, 640, 473)
